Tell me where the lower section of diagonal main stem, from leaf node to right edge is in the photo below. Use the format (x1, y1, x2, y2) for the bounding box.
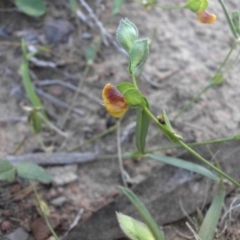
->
(178, 140, 240, 188)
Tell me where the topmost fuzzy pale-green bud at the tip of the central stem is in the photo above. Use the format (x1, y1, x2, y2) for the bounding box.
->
(117, 19, 138, 53)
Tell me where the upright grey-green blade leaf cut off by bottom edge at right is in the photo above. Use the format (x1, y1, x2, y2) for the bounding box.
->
(198, 191, 225, 240)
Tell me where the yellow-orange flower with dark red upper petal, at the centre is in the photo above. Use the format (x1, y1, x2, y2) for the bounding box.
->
(102, 83, 128, 118)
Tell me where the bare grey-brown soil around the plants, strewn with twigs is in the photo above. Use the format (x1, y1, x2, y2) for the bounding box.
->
(0, 0, 240, 240)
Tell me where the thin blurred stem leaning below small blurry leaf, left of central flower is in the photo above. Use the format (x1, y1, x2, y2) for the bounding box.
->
(59, 64, 91, 129)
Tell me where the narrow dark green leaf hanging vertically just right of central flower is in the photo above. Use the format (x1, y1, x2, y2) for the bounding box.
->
(135, 99, 150, 154)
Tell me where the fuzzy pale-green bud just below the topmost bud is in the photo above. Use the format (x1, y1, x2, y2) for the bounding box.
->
(128, 39, 149, 76)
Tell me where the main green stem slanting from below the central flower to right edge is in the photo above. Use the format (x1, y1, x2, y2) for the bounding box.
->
(143, 107, 240, 187)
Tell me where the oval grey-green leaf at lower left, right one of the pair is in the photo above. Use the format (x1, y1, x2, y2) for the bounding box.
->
(16, 163, 52, 183)
